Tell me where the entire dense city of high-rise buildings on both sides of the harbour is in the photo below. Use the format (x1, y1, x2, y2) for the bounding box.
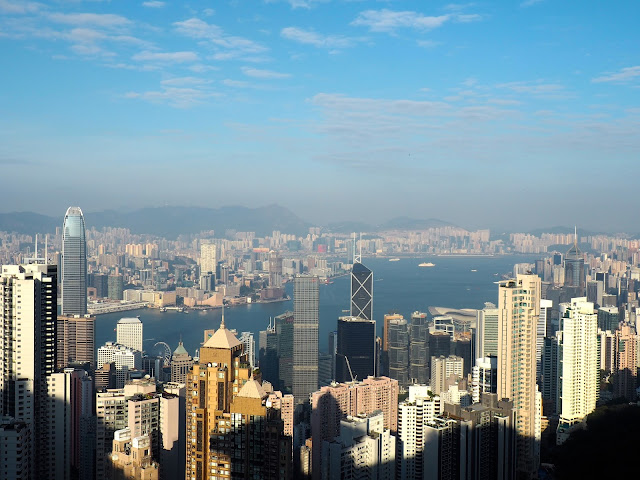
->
(0, 206, 640, 480)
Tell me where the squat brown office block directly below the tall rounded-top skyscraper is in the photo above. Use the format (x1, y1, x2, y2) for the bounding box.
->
(56, 315, 96, 369)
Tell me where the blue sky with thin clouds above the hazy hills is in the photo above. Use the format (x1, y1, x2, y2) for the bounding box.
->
(0, 0, 640, 232)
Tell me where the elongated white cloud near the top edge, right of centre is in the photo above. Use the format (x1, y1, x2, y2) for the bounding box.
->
(351, 8, 451, 32)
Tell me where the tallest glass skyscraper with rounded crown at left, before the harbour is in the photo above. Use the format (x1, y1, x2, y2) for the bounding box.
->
(61, 207, 87, 315)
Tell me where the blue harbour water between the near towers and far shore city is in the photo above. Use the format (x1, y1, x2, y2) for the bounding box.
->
(96, 255, 540, 355)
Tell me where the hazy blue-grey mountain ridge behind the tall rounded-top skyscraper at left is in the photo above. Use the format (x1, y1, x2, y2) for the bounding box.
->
(0, 205, 312, 238)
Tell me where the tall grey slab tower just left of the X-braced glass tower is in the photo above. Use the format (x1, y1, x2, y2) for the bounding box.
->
(292, 275, 320, 405)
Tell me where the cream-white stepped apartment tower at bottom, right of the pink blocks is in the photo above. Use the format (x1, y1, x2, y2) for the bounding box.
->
(396, 385, 444, 480)
